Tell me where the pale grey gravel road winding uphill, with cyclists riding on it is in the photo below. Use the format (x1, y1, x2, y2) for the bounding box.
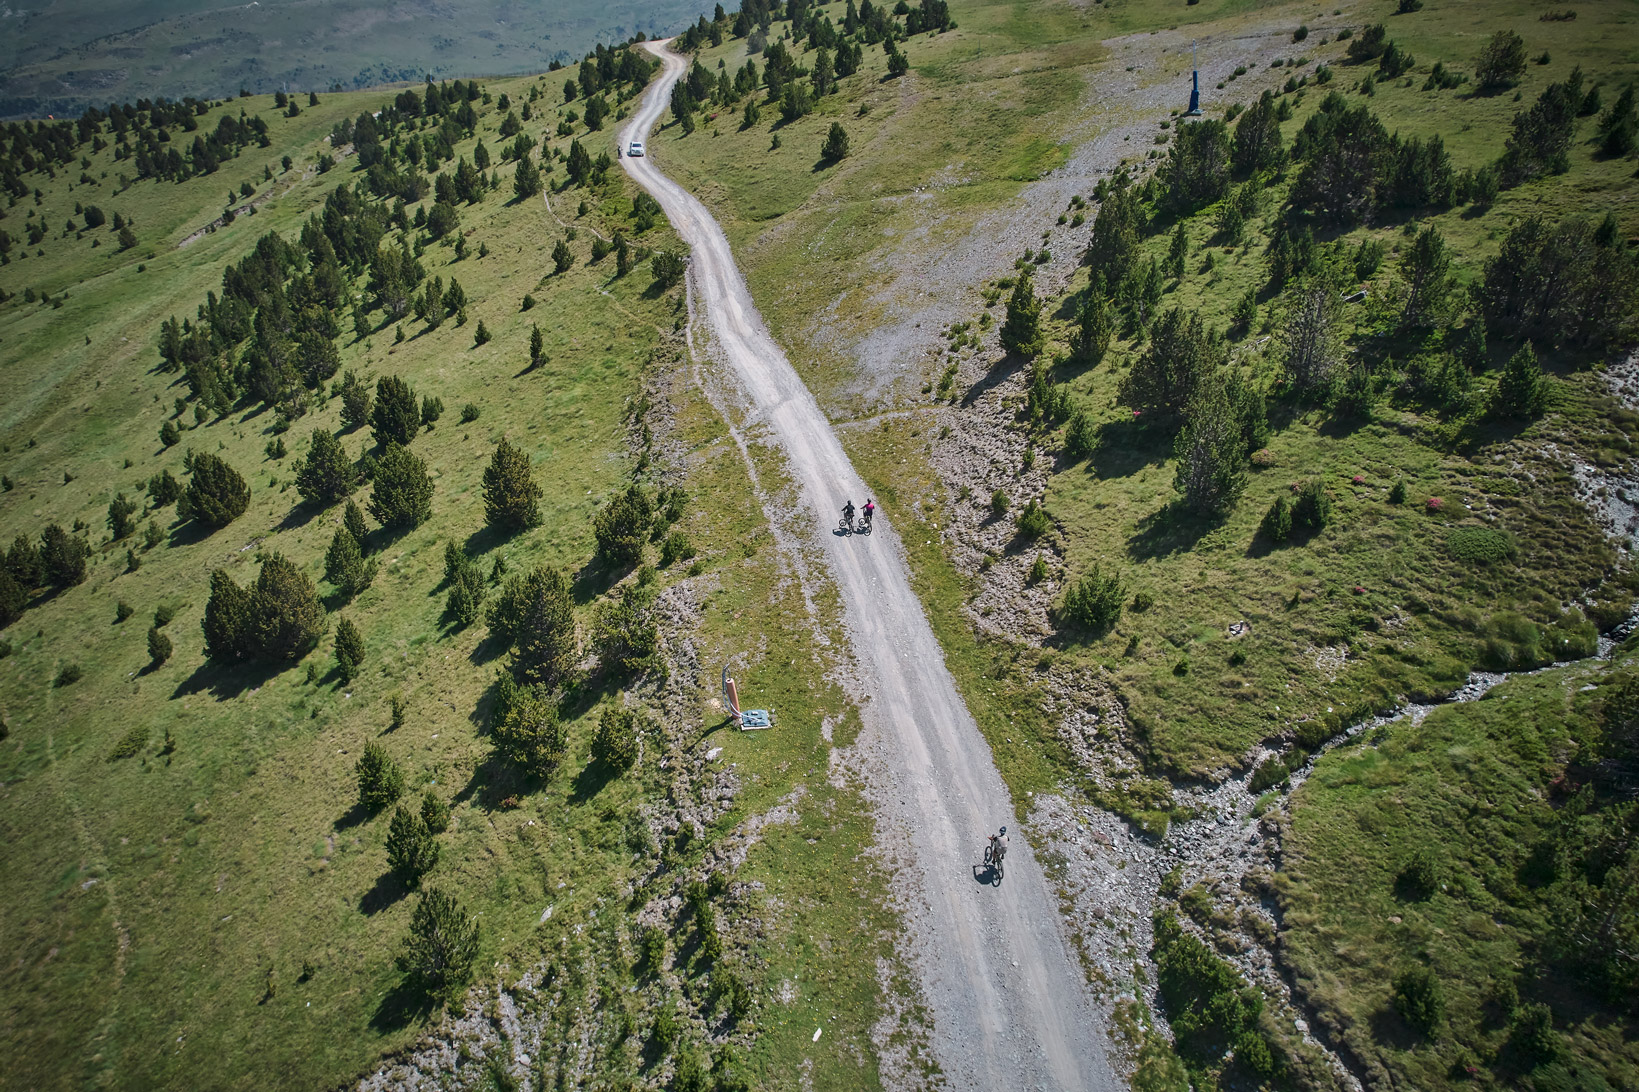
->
(620, 43, 1119, 1090)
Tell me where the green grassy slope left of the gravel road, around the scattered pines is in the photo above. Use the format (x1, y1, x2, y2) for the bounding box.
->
(0, 61, 892, 1089)
